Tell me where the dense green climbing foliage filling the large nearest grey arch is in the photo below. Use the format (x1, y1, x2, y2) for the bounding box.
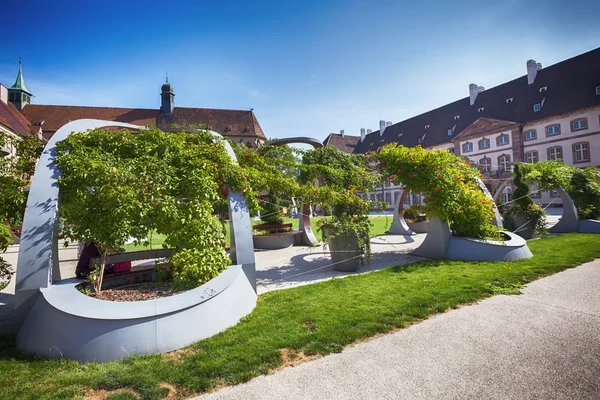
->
(56, 128, 256, 287)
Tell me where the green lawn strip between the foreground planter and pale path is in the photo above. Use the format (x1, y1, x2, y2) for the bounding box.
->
(0, 234, 600, 399)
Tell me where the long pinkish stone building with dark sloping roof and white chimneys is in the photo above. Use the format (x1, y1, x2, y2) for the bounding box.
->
(327, 48, 600, 208)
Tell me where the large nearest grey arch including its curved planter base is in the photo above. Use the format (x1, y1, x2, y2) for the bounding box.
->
(15, 119, 256, 362)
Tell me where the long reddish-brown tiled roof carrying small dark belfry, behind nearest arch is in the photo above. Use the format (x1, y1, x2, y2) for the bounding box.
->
(22, 104, 265, 139)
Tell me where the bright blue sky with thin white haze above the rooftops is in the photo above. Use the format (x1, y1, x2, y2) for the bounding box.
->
(0, 0, 600, 140)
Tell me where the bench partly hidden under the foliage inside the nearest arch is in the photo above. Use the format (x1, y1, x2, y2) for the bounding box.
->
(90, 249, 173, 289)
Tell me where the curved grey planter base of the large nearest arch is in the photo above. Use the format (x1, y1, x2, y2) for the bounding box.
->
(17, 265, 256, 363)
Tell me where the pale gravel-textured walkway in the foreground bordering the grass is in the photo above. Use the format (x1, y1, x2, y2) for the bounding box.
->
(198, 260, 600, 400)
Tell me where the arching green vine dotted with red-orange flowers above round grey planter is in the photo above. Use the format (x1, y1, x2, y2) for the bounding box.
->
(375, 145, 498, 239)
